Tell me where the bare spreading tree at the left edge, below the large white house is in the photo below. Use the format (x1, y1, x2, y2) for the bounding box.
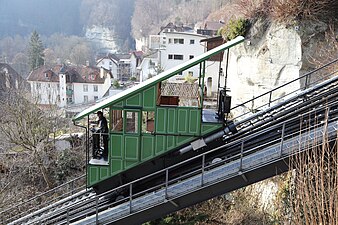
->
(0, 91, 54, 188)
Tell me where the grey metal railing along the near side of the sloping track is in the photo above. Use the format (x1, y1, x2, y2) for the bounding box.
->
(59, 103, 338, 224)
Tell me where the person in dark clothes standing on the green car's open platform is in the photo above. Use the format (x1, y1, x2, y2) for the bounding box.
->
(89, 111, 108, 164)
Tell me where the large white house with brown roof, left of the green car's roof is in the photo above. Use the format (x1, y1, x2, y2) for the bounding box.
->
(28, 65, 112, 107)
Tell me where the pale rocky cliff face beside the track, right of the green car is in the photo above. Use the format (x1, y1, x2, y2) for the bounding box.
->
(228, 20, 334, 112)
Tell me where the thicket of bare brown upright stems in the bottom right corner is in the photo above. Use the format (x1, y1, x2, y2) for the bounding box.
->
(278, 111, 338, 225)
